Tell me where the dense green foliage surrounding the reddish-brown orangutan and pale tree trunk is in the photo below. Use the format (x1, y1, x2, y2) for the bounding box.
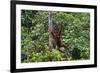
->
(21, 10, 90, 63)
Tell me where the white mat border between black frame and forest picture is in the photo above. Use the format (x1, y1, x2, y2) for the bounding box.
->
(16, 5, 94, 69)
